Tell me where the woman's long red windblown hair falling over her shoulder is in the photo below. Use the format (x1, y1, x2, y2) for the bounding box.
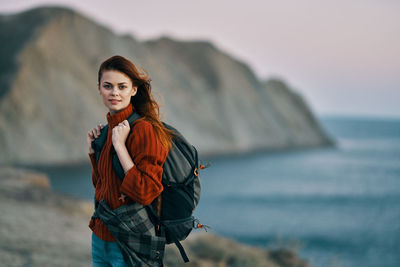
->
(98, 55, 174, 151)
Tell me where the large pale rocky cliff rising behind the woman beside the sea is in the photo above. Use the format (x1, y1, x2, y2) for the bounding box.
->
(0, 7, 330, 164)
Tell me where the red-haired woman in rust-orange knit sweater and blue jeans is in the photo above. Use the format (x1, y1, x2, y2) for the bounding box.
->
(87, 56, 173, 266)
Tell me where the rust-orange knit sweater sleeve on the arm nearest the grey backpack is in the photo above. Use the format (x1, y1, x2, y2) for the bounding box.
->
(120, 120, 167, 205)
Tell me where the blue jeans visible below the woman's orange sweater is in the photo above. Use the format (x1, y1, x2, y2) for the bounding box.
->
(92, 232, 126, 267)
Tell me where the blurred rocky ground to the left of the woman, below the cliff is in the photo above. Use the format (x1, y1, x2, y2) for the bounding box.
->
(0, 167, 91, 267)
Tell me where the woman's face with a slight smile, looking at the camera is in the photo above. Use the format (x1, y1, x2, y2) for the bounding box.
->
(97, 70, 137, 115)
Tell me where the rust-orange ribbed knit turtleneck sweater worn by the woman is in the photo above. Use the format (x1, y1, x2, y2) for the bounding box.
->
(89, 104, 168, 241)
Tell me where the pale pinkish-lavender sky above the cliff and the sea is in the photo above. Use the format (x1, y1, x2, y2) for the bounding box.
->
(0, 0, 400, 118)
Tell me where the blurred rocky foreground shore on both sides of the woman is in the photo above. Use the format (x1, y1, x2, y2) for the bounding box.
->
(0, 166, 310, 267)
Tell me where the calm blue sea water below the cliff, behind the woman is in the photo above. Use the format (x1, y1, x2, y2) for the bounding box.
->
(35, 117, 400, 267)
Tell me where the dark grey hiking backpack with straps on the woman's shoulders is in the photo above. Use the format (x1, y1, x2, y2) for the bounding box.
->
(92, 111, 208, 262)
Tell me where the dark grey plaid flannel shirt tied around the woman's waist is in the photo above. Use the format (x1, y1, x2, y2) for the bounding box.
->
(92, 197, 166, 267)
